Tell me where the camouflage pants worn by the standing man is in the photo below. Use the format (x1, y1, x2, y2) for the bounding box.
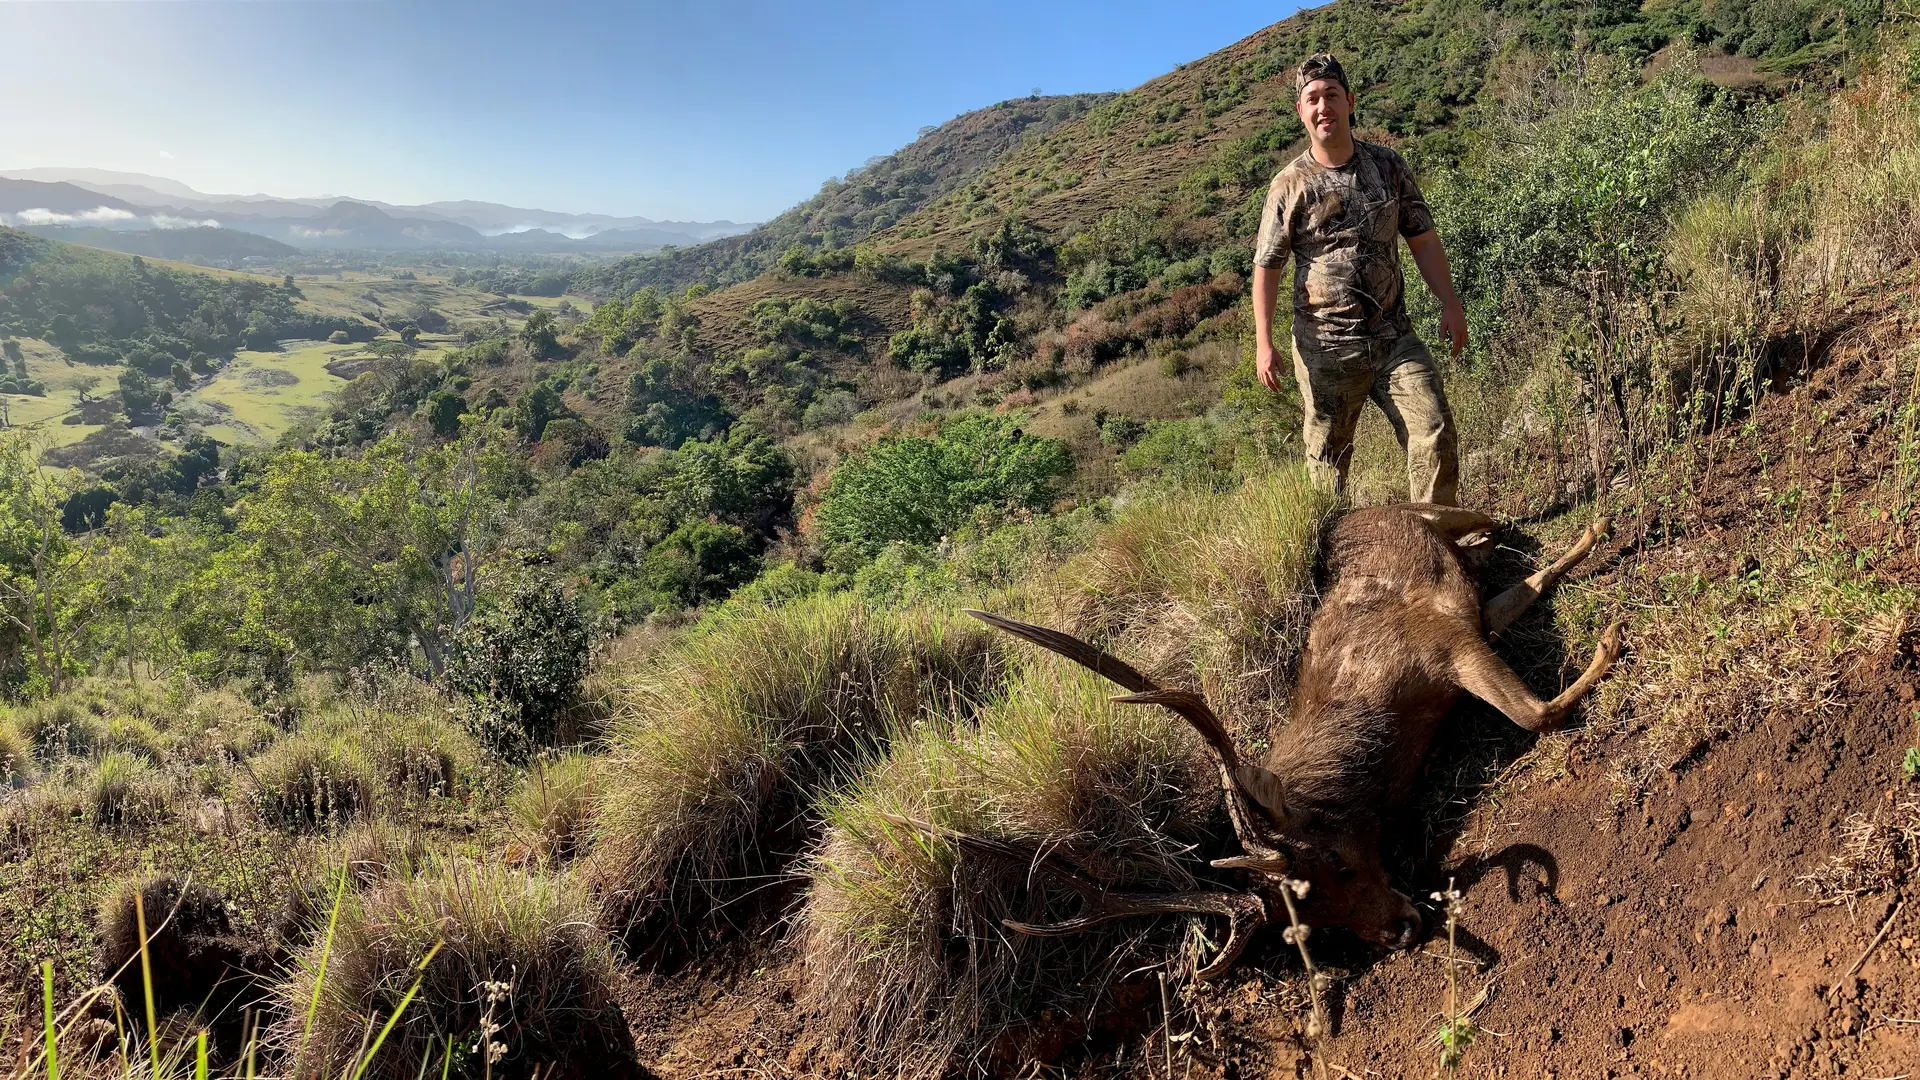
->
(1294, 332, 1459, 505)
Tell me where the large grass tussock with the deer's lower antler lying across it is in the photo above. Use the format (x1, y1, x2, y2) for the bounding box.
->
(801, 659, 1217, 1076)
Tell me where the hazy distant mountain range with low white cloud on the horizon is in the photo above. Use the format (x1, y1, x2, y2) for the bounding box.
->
(0, 169, 753, 258)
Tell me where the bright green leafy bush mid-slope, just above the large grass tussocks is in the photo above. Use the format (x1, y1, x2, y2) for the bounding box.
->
(814, 413, 1073, 555)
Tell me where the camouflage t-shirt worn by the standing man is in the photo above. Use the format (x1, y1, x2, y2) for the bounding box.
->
(1254, 138, 1434, 342)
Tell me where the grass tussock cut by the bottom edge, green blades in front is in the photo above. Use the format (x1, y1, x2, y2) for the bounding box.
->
(273, 861, 632, 1080)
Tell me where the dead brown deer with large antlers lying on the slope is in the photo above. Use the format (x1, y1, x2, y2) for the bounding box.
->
(944, 503, 1620, 978)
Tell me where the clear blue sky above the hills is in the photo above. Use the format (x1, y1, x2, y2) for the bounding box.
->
(0, 0, 1298, 221)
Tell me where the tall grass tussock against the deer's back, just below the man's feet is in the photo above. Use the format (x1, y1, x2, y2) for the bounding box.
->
(1062, 465, 1334, 713)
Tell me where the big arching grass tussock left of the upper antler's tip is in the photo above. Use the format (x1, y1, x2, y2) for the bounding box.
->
(586, 594, 1004, 926)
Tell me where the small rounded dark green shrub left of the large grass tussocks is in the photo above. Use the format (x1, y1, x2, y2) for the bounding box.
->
(447, 580, 593, 761)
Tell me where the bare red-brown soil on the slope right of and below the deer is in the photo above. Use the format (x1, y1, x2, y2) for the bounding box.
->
(610, 304, 1920, 1078)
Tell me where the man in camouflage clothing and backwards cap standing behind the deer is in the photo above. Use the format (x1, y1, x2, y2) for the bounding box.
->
(1254, 54, 1467, 505)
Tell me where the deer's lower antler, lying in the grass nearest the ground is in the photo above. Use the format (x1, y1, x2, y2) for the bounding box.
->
(879, 813, 1267, 980)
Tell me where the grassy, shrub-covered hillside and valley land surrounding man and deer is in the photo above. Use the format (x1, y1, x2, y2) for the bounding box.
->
(0, 0, 1920, 1078)
